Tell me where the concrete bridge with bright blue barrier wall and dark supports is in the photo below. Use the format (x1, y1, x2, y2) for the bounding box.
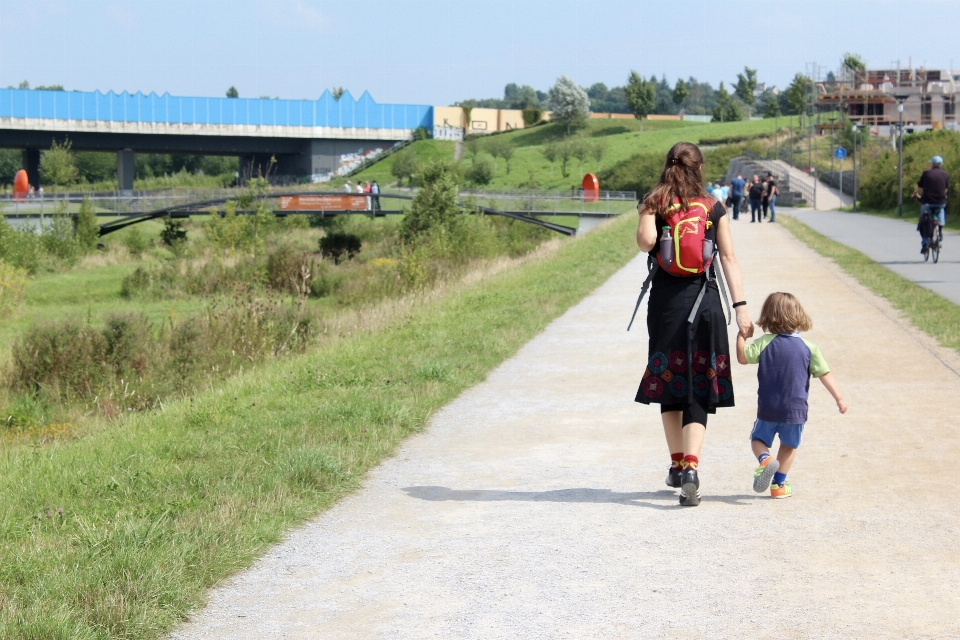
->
(0, 89, 434, 191)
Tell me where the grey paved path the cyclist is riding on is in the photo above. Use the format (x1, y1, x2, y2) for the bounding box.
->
(782, 209, 960, 304)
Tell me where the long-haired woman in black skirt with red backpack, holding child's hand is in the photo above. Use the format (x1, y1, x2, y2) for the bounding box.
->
(636, 142, 753, 506)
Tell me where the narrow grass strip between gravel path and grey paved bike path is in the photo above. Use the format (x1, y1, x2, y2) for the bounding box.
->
(782, 216, 960, 353)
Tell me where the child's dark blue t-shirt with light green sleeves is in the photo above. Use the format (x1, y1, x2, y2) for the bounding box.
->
(743, 333, 830, 424)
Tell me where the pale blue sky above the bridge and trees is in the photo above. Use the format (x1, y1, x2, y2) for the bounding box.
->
(0, 0, 960, 105)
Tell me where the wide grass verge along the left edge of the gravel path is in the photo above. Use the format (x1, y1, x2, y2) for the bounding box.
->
(0, 216, 636, 638)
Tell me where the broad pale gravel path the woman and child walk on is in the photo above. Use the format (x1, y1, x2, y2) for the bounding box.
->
(174, 218, 960, 640)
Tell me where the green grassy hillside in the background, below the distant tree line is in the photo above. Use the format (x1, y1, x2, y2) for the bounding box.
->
(344, 119, 774, 189)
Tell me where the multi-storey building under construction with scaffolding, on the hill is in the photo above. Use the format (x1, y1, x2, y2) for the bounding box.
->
(815, 68, 960, 133)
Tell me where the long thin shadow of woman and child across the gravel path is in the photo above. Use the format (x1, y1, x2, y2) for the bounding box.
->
(403, 487, 764, 509)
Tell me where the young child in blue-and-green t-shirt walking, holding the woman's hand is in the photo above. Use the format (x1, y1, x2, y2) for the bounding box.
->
(737, 293, 847, 498)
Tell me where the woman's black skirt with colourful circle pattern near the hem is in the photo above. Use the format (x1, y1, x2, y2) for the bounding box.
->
(636, 271, 733, 413)
